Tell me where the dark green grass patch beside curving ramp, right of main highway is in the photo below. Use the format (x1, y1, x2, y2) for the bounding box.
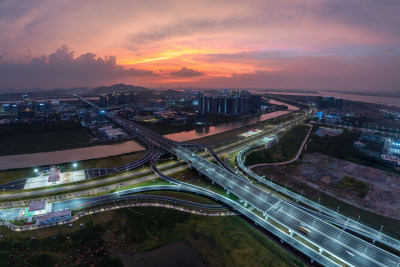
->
(245, 125, 310, 166)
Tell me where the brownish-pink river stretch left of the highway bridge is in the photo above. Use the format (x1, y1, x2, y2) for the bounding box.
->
(0, 141, 145, 170)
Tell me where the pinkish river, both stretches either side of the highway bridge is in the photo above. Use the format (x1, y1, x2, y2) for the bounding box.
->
(0, 100, 298, 170)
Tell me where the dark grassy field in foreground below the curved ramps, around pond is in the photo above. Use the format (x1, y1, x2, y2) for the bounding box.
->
(0, 207, 304, 266)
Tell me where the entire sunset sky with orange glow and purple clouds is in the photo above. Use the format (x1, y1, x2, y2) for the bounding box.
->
(0, 0, 400, 92)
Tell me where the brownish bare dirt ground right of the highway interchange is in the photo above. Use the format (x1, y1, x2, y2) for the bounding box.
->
(261, 153, 400, 219)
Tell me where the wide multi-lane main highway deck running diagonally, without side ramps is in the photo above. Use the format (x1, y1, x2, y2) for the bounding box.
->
(108, 113, 400, 266)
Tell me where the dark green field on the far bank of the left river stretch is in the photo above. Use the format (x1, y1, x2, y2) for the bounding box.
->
(0, 122, 91, 155)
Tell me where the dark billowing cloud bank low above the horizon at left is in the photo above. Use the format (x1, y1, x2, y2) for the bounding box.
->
(0, 45, 154, 90)
